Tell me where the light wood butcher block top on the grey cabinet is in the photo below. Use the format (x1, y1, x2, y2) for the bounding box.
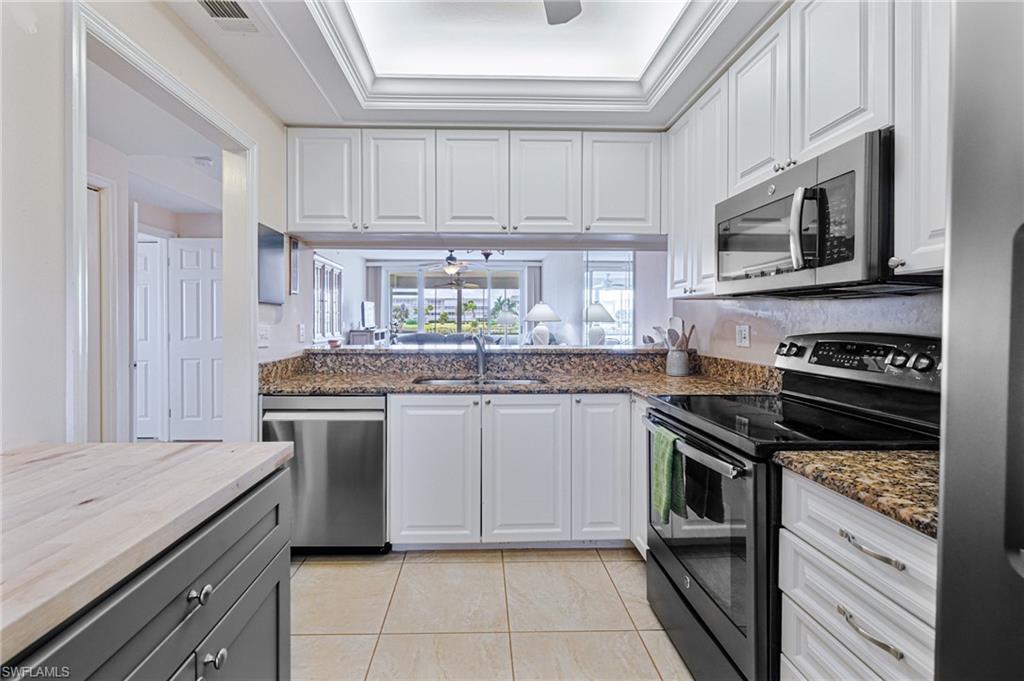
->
(0, 442, 292, 661)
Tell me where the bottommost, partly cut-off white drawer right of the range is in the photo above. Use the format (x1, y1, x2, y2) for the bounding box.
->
(779, 596, 880, 681)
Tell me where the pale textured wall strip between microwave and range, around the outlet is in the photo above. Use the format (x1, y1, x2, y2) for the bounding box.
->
(674, 292, 942, 365)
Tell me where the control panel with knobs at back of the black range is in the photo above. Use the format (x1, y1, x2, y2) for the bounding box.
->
(775, 334, 942, 392)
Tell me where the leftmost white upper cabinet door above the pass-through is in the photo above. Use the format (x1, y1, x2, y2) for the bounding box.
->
(288, 128, 360, 231)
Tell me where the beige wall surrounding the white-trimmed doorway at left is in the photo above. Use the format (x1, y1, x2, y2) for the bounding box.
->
(0, 2, 286, 449)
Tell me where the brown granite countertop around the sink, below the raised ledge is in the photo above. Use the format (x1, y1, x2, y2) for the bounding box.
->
(262, 372, 764, 397)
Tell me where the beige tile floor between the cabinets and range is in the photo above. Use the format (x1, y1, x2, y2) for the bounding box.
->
(292, 549, 692, 681)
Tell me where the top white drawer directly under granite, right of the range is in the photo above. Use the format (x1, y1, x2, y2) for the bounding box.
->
(782, 471, 938, 627)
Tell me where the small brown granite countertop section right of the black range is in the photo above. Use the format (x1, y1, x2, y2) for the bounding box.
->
(774, 450, 939, 539)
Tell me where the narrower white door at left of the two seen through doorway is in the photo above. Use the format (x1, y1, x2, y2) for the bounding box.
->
(134, 239, 167, 440)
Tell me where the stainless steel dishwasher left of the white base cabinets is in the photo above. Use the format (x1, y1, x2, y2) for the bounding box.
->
(262, 396, 391, 552)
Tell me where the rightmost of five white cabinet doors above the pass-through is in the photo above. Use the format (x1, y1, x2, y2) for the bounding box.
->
(583, 132, 662, 235)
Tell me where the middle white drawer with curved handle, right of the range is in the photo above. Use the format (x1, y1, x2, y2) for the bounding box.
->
(778, 529, 935, 679)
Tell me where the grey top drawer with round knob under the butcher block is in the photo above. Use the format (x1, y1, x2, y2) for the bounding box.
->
(26, 470, 292, 681)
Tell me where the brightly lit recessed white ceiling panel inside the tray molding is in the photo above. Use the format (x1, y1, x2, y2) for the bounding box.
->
(348, 0, 686, 80)
